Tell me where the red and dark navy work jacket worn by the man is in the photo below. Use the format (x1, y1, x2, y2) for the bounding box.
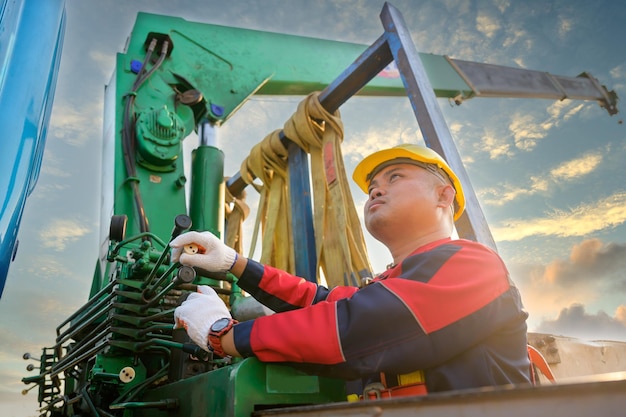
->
(234, 239, 530, 392)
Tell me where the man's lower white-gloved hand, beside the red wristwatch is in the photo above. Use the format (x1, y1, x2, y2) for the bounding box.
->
(174, 285, 231, 352)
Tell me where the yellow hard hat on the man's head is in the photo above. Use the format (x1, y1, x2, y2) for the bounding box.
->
(352, 144, 465, 221)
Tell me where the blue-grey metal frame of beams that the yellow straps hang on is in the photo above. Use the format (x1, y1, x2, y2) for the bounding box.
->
(232, 3, 496, 281)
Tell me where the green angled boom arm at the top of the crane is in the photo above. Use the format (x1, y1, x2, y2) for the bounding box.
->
(127, 13, 471, 121)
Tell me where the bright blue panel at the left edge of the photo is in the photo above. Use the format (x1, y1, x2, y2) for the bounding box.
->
(0, 0, 65, 296)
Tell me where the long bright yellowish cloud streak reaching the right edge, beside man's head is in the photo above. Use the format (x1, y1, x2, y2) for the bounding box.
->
(492, 192, 626, 241)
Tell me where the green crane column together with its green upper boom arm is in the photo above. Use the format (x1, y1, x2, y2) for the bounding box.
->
(108, 13, 471, 252)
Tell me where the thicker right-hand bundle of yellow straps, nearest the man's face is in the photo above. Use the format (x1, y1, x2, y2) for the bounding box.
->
(284, 93, 371, 287)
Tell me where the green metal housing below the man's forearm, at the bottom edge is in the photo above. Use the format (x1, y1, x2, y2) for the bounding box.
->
(133, 358, 346, 417)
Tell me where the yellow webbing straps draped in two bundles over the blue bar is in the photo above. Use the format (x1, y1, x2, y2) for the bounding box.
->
(240, 93, 371, 287)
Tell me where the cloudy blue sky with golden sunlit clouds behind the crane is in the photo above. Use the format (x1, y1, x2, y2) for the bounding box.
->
(0, 0, 626, 417)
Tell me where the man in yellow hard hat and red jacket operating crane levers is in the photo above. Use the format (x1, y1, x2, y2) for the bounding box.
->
(171, 144, 530, 392)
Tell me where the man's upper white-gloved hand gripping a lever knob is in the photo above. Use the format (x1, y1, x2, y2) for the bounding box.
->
(170, 232, 237, 272)
